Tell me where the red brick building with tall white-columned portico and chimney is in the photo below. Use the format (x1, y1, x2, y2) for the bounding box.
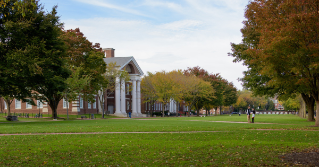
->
(0, 48, 187, 117)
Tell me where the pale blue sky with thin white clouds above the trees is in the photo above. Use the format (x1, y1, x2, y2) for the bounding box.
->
(40, 0, 248, 89)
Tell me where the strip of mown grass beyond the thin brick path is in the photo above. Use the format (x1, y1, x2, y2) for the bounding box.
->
(0, 115, 319, 133)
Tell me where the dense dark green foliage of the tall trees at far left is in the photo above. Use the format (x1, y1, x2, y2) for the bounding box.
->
(0, 0, 70, 118)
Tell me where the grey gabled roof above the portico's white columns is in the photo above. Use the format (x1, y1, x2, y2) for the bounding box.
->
(103, 56, 144, 75)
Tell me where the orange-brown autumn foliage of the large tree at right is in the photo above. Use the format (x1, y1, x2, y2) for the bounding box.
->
(232, 0, 319, 126)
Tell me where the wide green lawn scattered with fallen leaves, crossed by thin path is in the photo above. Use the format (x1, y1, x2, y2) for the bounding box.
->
(0, 115, 319, 166)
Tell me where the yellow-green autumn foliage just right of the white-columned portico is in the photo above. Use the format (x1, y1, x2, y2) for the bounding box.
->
(141, 70, 214, 113)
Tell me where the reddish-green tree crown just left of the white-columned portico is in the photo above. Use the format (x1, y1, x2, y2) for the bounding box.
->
(60, 28, 108, 102)
